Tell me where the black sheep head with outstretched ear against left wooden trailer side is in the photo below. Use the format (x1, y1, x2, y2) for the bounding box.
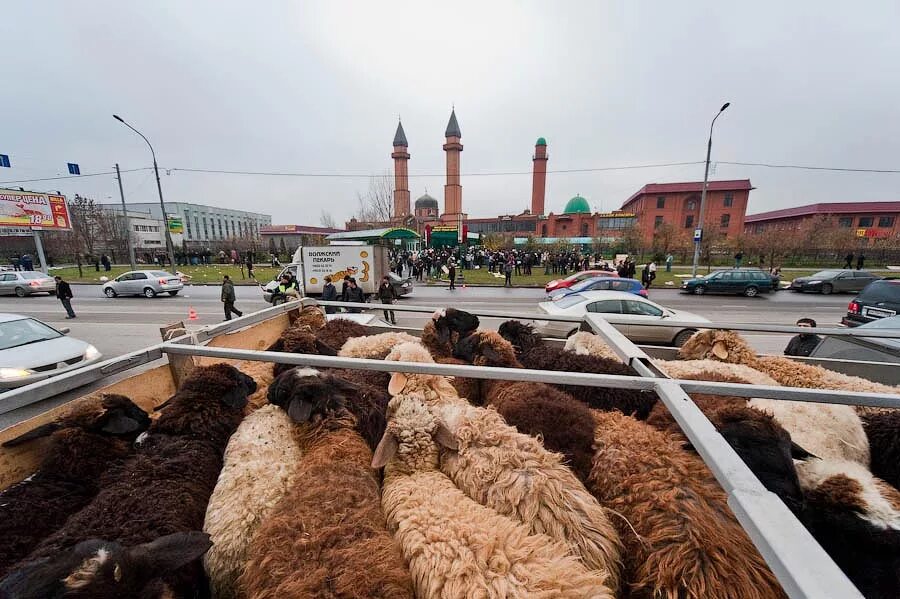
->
(3, 394, 150, 447)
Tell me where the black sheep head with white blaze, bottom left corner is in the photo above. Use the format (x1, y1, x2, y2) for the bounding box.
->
(0, 531, 212, 599)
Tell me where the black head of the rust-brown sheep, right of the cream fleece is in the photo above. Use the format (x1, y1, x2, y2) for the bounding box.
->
(268, 368, 359, 423)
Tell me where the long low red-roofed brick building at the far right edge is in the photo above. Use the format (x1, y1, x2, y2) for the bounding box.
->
(744, 202, 900, 239)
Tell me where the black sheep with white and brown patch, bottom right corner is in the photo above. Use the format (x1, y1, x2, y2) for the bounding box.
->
(797, 458, 900, 599)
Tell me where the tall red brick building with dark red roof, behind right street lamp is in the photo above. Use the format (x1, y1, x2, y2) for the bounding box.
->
(620, 179, 753, 242)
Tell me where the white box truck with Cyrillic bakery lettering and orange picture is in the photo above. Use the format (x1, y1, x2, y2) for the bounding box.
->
(263, 245, 390, 302)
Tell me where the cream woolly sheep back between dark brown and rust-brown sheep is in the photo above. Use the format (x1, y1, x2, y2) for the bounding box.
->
(203, 405, 301, 599)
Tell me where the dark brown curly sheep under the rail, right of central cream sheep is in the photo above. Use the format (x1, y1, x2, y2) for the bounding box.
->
(456, 331, 594, 481)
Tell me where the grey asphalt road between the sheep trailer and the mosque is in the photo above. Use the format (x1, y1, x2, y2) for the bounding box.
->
(0, 285, 852, 357)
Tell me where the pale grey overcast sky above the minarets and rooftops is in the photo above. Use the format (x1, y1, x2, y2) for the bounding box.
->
(0, 0, 900, 224)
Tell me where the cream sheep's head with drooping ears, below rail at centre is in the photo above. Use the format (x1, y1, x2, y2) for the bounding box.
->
(372, 395, 459, 472)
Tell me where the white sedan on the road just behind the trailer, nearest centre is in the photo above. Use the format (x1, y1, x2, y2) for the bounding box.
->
(535, 291, 709, 347)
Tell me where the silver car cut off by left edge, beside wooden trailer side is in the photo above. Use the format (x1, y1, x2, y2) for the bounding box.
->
(0, 314, 102, 389)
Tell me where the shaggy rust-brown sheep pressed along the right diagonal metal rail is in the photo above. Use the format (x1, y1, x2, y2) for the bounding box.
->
(589, 411, 784, 599)
